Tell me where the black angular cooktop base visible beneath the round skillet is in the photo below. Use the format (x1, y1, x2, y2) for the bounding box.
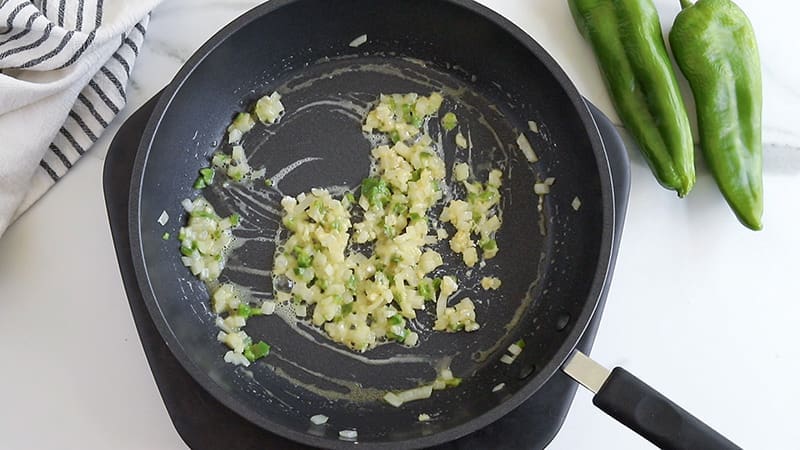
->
(103, 96, 630, 450)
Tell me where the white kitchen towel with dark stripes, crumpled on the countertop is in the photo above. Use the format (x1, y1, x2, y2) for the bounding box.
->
(0, 0, 161, 235)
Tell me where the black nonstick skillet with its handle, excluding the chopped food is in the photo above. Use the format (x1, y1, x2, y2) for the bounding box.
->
(129, 0, 735, 448)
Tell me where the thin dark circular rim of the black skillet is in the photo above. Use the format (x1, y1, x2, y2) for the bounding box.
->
(128, 0, 618, 449)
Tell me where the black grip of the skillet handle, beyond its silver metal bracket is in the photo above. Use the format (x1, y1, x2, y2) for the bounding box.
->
(593, 367, 740, 450)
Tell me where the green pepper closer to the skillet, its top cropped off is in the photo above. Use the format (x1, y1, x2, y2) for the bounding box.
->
(569, 0, 695, 197)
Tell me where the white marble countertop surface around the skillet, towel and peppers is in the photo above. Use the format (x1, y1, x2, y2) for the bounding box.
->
(0, 0, 800, 449)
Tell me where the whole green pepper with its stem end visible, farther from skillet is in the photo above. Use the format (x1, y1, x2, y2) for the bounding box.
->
(669, 0, 764, 230)
